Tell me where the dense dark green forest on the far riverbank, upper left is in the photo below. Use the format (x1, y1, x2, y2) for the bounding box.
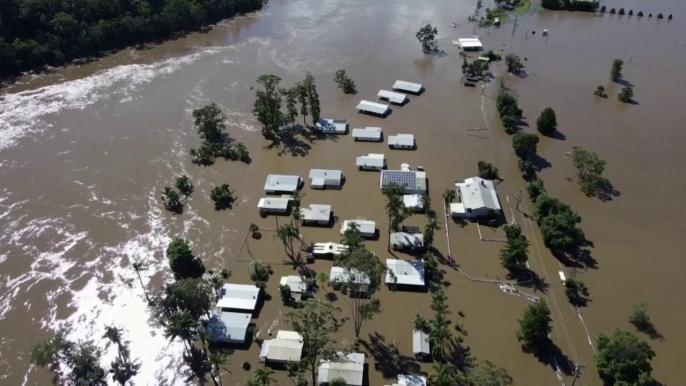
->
(0, 0, 263, 79)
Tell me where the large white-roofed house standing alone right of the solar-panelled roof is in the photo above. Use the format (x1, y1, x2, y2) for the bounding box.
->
(450, 177, 502, 219)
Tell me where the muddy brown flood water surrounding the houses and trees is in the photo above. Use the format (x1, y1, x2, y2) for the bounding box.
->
(0, 0, 686, 386)
